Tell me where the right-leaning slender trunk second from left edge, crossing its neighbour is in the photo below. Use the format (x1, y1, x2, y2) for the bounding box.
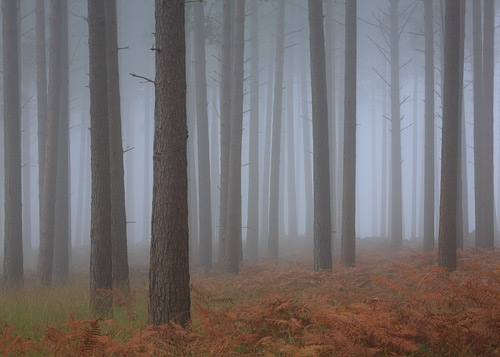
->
(37, 0, 62, 287)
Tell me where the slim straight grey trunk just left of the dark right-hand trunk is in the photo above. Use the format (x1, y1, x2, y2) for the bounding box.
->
(423, 0, 435, 252)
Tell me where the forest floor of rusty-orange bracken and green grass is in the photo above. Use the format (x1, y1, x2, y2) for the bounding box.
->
(0, 242, 500, 356)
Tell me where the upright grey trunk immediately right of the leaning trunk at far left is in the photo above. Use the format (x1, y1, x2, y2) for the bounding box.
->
(53, 0, 71, 284)
